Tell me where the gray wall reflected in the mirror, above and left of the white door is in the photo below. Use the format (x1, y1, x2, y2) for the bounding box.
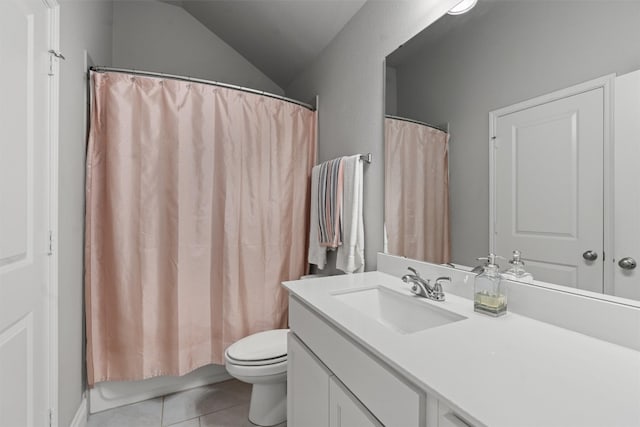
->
(397, 1, 640, 265)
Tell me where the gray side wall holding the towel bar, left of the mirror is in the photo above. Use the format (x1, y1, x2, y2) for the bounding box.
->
(286, 0, 457, 272)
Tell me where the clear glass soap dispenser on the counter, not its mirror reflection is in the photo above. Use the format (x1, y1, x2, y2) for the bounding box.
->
(473, 254, 507, 317)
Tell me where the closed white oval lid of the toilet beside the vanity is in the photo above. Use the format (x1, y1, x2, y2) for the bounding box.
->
(227, 329, 289, 363)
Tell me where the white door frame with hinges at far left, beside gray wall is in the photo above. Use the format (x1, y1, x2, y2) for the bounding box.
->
(42, 0, 60, 427)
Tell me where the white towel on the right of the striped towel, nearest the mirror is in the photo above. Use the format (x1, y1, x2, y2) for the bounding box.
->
(338, 155, 364, 273)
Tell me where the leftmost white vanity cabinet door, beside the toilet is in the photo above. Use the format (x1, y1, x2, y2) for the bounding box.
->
(287, 332, 331, 427)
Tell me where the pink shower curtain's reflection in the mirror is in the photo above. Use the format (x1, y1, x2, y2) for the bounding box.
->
(384, 118, 451, 264)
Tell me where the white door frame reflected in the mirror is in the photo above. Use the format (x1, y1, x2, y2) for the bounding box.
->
(489, 74, 616, 295)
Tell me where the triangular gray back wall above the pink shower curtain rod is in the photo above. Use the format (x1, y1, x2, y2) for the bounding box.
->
(113, 0, 284, 95)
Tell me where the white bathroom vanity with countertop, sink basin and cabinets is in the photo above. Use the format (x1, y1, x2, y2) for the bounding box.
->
(284, 262, 640, 427)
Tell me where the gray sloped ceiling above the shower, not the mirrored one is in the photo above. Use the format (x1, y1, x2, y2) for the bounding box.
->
(166, 0, 366, 89)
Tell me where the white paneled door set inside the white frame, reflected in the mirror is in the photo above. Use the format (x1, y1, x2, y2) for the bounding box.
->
(491, 80, 606, 292)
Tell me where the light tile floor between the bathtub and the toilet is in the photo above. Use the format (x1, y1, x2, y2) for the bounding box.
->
(88, 380, 287, 427)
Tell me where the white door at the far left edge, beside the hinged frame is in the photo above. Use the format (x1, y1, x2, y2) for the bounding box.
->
(0, 0, 49, 427)
